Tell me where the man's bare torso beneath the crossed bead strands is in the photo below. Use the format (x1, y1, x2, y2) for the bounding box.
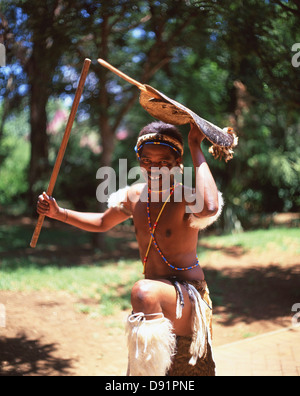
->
(127, 184, 204, 280)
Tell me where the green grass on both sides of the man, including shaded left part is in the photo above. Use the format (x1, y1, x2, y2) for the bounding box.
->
(0, 221, 300, 316)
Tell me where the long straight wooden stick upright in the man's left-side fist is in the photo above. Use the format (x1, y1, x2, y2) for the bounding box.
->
(30, 58, 91, 248)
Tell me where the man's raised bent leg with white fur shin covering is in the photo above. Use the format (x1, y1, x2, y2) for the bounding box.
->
(126, 279, 192, 376)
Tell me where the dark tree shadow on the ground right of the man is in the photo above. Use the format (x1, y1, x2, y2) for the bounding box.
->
(205, 264, 300, 326)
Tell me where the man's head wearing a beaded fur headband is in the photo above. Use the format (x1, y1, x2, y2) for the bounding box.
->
(135, 122, 183, 188)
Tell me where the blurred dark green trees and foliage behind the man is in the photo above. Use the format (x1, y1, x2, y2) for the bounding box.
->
(0, 0, 300, 231)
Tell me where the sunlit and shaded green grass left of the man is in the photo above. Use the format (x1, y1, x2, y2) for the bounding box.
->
(0, 224, 142, 315)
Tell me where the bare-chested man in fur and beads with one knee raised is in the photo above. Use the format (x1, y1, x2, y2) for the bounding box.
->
(37, 122, 222, 376)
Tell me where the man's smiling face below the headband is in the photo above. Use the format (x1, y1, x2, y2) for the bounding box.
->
(140, 144, 181, 188)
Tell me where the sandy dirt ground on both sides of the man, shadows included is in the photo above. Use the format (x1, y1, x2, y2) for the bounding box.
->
(0, 218, 300, 376)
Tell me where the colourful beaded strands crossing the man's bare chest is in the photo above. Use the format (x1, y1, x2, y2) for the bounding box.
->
(144, 183, 199, 274)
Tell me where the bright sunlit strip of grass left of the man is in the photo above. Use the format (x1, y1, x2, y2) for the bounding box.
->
(0, 257, 142, 315)
